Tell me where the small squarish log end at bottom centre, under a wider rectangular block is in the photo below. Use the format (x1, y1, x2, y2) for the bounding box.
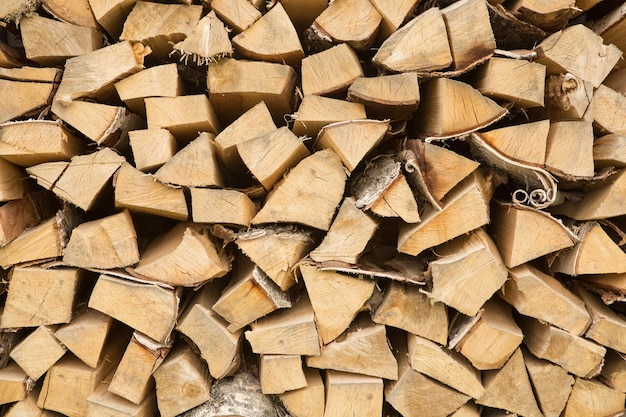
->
(259, 355, 307, 394)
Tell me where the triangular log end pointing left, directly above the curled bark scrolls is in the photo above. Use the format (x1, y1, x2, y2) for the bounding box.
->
(480, 118, 544, 165)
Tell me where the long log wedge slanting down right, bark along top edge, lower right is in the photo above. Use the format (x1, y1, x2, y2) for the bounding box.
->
(408, 333, 485, 398)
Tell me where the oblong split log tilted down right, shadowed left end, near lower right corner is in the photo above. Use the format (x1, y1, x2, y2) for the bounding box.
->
(518, 317, 606, 378)
